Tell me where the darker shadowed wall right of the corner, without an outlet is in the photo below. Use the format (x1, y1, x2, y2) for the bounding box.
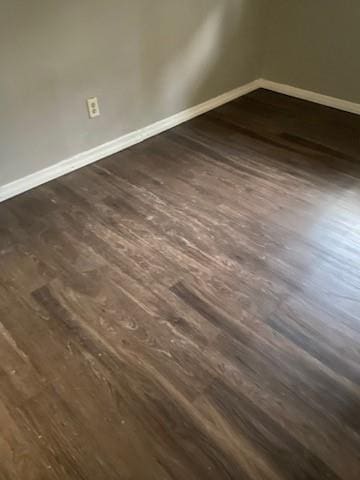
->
(262, 0, 360, 103)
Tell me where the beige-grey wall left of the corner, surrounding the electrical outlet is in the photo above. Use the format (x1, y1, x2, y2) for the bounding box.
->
(0, 0, 264, 185)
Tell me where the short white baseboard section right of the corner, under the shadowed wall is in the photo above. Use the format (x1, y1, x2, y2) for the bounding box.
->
(258, 78, 360, 115)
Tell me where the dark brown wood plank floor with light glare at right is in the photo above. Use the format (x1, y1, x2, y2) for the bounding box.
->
(0, 90, 360, 480)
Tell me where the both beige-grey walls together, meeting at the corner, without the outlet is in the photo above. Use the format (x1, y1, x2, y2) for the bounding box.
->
(0, 0, 360, 186)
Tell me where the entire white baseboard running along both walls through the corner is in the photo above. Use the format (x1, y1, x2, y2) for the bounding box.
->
(0, 78, 360, 202)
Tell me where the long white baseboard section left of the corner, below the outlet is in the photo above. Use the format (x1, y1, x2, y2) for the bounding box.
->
(0, 80, 259, 202)
